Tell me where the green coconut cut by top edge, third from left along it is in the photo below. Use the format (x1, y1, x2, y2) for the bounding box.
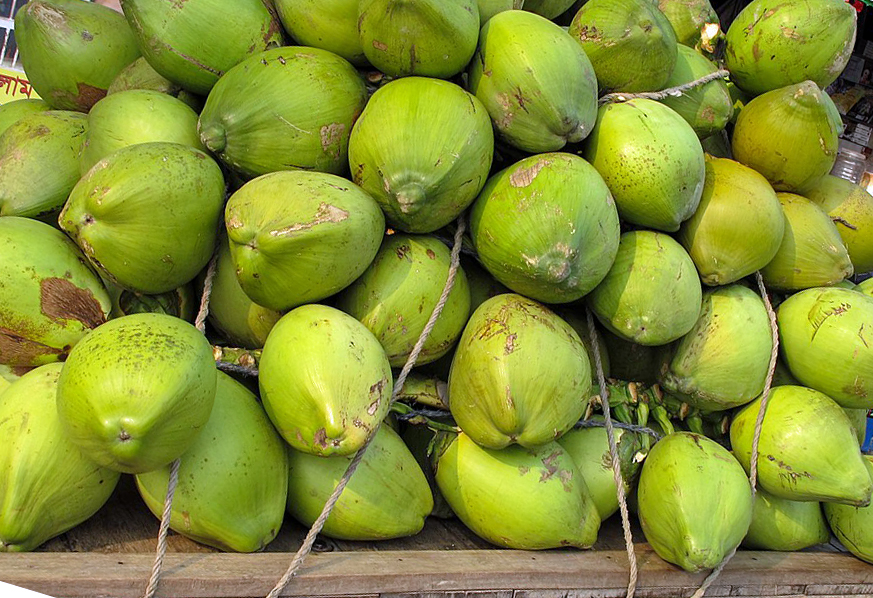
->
(273, 0, 368, 66)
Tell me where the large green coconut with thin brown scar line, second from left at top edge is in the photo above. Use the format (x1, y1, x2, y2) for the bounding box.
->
(121, 0, 283, 96)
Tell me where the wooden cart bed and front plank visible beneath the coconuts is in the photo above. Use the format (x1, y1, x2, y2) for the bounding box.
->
(0, 478, 873, 598)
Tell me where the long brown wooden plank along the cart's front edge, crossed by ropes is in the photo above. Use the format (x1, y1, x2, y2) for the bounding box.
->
(0, 545, 873, 598)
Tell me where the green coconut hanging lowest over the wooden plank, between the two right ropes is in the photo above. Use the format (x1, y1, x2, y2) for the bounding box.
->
(637, 432, 753, 573)
